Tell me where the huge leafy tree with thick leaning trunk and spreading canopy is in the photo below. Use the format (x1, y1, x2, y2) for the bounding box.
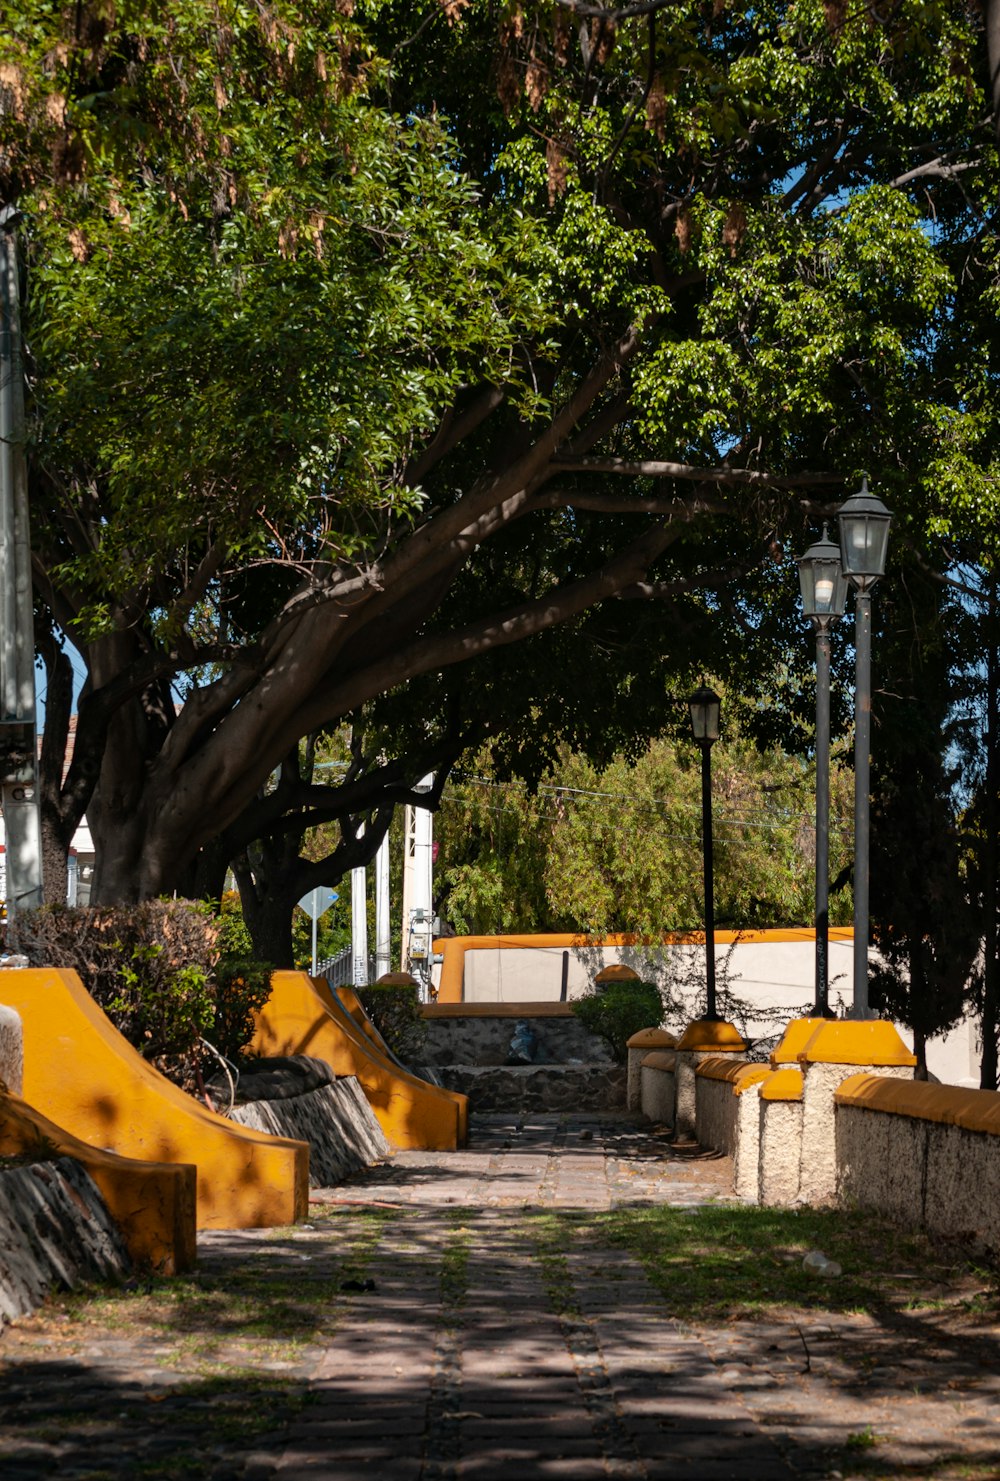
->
(0, 0, 991, 899)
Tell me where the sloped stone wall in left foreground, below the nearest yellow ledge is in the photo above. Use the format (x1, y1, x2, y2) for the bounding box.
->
(0, 1157, 130, 1323)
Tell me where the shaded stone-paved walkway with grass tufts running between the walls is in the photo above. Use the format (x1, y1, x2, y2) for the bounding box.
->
(0, 1117, 1000, 1481)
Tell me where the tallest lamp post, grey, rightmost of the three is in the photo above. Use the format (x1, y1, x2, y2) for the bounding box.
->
(837, 478, 892, 1019)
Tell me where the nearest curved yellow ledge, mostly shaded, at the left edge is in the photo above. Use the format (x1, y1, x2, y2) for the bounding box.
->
(0, 1093, 197, 1275)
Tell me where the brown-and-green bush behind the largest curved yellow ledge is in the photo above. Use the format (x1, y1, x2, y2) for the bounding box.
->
(18, 900, 271, 1089)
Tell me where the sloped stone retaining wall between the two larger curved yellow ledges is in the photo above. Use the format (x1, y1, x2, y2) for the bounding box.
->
(230, 1075, 390, 1188)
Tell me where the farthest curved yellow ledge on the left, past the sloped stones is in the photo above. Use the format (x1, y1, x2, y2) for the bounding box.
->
(253, 972, 468, 1151)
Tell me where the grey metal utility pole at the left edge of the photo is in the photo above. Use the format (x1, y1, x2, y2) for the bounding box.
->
(0, 206, 41, 945)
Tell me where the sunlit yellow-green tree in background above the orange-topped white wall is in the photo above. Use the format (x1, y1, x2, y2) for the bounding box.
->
(439, 724, 850, 937)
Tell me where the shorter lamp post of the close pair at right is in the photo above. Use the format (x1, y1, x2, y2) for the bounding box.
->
(797, 524, 847, 1017)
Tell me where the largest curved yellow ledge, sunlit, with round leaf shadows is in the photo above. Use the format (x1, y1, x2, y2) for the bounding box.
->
(0, 967, 310, 1229)
